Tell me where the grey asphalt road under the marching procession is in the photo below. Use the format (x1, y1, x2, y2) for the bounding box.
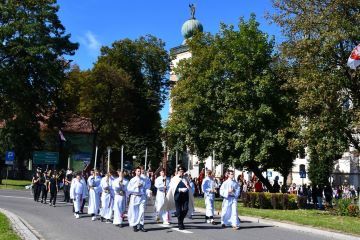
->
(0, 190, 329, 240)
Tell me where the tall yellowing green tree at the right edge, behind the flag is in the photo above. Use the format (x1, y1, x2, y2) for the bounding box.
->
(271, 0, 360, 184)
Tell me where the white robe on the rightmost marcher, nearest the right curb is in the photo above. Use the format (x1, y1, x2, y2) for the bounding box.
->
(220, 179, 240, 227)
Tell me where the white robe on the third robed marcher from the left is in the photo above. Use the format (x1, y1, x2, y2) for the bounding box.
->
(100, 176, 114, 220)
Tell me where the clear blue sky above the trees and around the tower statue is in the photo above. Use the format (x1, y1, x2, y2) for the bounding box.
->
(58, 0, 282, 120)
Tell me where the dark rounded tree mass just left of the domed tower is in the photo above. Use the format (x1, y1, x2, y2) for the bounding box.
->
(80, 36, 170, 171)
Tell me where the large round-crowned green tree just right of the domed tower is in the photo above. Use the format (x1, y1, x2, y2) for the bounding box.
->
(168, 15, 294, 190)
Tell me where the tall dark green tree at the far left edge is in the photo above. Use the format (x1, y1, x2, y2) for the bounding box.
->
(0, 0, 78, 172)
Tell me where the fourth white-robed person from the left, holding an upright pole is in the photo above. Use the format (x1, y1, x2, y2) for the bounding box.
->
(112, 170, 128, 227)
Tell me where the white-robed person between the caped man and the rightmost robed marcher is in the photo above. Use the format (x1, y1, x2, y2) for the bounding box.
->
(201, 170, 216, 225)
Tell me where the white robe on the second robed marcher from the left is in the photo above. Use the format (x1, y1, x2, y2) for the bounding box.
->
(88, 176, 102, 215)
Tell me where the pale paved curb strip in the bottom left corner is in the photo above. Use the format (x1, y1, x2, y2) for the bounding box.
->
(0, 208, 44, 240)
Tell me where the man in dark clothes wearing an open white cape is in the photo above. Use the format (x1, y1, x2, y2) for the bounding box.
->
(160, 166, 194, 230)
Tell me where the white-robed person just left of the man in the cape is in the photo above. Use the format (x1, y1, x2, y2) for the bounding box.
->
(155, 169, 170, 225)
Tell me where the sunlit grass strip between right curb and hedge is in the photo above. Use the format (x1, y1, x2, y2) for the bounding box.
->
(195, 198, 360, 236)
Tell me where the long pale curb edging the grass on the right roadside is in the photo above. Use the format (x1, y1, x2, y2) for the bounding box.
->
(196, 208, 359, 240)
